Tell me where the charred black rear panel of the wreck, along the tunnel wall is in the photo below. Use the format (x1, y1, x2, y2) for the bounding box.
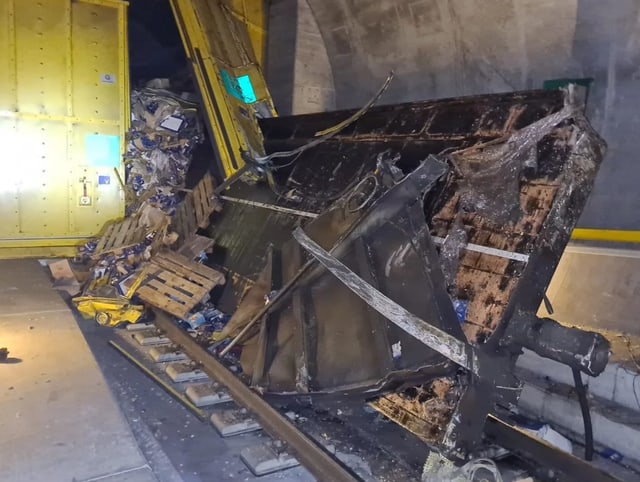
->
(209, 91, 563, 310)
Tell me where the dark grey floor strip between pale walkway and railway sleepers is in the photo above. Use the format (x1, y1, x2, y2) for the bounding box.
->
(70, 292, 314, 482)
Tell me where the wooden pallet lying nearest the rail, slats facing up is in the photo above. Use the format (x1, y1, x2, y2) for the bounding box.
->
(136, 252, 224, 318)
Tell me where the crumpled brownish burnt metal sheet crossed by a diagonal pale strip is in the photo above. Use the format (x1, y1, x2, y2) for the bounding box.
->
(218, 159, 465, 392)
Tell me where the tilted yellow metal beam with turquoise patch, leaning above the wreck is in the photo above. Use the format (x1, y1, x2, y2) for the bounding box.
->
(170, 0, 275, 178)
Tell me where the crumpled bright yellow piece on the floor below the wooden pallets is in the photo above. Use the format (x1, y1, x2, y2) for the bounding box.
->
(72, 296, 144, 327)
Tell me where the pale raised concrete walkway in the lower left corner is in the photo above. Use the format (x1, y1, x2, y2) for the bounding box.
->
(0, 260, 157, 482)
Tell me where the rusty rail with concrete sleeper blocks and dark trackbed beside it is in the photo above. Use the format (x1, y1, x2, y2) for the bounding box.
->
(111, 312, 428, 481)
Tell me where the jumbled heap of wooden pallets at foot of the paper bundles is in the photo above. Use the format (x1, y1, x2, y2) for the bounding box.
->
(77, 173, 225, 321)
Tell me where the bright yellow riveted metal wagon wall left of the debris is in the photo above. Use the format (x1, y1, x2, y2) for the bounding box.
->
(0, 0, 129, 258)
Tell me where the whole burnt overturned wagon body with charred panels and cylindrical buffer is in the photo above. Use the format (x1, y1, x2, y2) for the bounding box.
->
(213, 87, 608, 457)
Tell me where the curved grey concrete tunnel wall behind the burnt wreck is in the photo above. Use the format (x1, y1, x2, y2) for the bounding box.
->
(267, 0, 640, 230)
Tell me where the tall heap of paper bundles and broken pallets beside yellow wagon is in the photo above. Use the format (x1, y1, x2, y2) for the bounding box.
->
(66, 81, 226, 331)
